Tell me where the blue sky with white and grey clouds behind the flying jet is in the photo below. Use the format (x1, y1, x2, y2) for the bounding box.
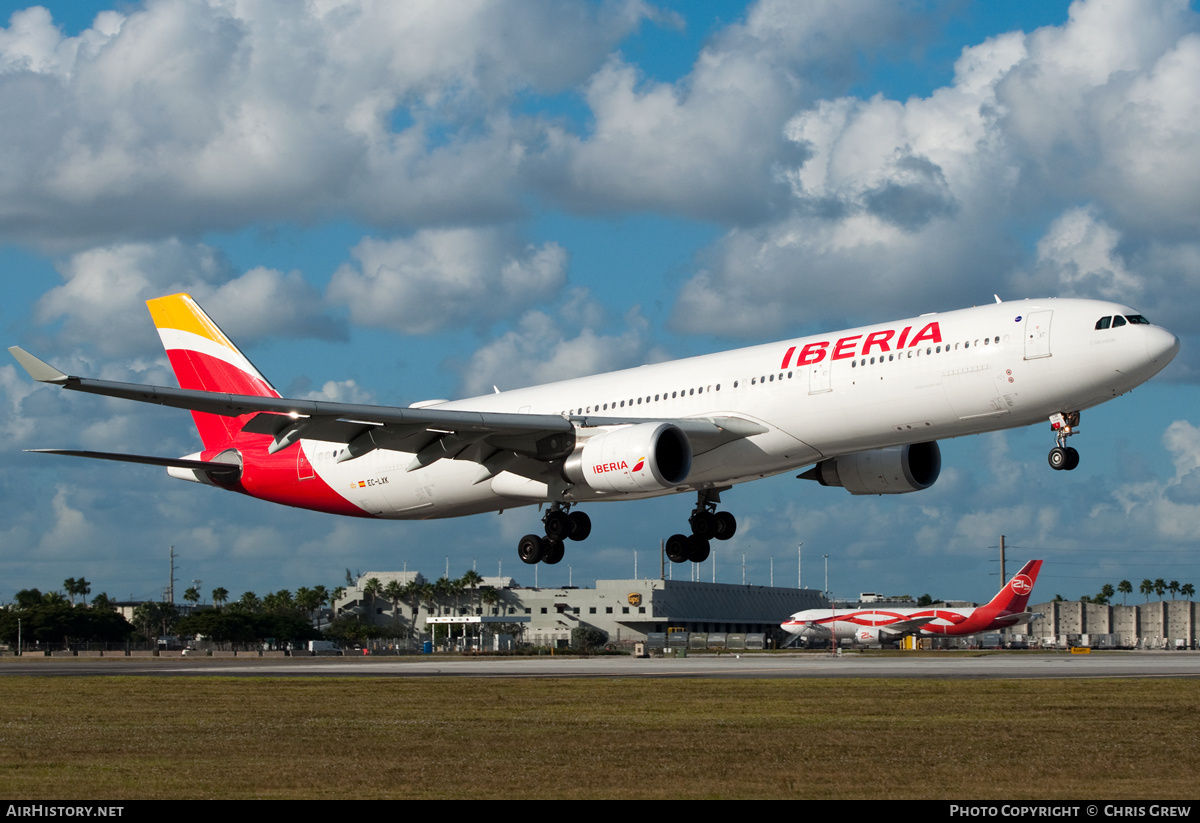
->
(0, 1, 1200, 600)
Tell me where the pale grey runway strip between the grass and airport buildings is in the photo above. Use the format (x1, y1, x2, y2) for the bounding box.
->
(0, 651, 1200, 680)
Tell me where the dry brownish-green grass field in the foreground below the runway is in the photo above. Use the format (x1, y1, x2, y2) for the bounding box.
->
(0, 677, 1200, 800)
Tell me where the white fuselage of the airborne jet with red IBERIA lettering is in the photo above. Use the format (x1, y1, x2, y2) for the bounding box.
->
(301, 299, 1178, 518)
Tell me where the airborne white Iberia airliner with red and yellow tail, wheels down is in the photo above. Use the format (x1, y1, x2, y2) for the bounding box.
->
(8, 294, 1180, 563)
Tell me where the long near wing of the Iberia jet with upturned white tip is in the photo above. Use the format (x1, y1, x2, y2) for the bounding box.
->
(8, 346, 767, 475)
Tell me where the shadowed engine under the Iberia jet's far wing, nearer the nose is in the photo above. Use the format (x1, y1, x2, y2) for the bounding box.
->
(799, 441, 942, 494)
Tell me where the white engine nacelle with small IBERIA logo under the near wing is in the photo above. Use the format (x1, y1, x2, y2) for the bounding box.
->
(563, 423, 691, 494)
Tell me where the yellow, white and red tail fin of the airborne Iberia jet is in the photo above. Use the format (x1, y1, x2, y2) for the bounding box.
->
(146, 294, 280, 449)
